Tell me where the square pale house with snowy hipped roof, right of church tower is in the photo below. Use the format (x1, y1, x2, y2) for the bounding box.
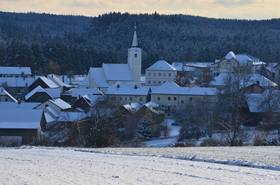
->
(145, 59, 177, 86)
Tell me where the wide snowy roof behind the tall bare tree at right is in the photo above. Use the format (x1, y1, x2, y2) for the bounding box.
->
(211, 74, 278, 87)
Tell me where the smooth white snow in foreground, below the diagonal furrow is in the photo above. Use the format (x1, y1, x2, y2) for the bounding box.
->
(0, 147, 280, 184)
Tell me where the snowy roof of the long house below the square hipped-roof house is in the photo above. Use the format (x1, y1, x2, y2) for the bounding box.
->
(151, 81, 219, 96)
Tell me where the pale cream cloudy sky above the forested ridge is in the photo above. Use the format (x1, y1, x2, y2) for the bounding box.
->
(0, 0, 280, 20)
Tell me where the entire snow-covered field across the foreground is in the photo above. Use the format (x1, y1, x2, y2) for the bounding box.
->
(0, 147, 280, 184)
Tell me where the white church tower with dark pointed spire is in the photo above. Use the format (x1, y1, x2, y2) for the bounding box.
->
(127, 26, 142, 86)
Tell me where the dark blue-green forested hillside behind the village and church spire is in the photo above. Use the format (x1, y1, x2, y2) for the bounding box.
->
(0, 12, 280, 74)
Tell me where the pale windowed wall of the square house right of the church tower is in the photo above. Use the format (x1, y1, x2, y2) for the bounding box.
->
(145, 70, 177, 86)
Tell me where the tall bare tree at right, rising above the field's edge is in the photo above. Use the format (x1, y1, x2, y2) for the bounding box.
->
(217, 74, 250, 146)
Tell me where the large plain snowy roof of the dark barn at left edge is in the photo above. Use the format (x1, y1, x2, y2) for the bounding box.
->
(0, 109, 42, 129)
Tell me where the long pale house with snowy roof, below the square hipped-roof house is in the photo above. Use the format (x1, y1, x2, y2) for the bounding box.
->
(151, 81, 219, 117)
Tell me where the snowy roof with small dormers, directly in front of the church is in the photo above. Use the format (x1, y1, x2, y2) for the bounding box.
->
(106, 82, 150, 96)
